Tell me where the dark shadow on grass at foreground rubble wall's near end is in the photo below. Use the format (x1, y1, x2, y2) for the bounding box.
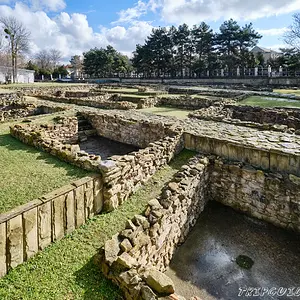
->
(75, 257, 123, 300)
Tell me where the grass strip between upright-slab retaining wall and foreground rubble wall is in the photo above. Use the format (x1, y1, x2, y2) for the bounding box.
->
(0, 150, 195, 300)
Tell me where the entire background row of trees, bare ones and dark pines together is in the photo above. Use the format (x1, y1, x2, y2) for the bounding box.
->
(0, 13, 300, 82)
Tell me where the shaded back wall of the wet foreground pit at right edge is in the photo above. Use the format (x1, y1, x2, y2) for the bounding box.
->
(208, 160, 300, 232)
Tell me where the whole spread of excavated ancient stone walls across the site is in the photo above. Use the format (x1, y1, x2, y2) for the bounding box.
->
(0, 87, 300, 300)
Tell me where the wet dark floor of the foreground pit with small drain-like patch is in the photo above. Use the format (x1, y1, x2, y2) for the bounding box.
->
(166, 202, 300, 300)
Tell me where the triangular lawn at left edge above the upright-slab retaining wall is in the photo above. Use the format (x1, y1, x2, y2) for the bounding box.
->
(0, 123, 88, 213)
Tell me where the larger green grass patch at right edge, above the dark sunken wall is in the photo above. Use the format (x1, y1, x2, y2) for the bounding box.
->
(238, 96, 300, 107)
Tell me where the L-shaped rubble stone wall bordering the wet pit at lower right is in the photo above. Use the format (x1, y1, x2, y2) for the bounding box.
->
(97, 156, 300, 300)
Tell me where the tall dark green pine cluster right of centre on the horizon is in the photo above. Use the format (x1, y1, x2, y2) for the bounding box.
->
(132, 19, 262, 77)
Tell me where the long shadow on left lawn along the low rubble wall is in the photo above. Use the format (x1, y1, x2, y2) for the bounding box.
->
(0, 133, 89, 176)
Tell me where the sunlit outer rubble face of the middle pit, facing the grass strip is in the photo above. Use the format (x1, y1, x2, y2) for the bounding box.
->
(100, 133, 183, 211)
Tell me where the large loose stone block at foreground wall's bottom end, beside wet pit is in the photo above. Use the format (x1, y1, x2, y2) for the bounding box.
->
(146, 269, 175, 294)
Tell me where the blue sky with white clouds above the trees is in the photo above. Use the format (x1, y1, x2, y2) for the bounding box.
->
(0, 0, 300, 61)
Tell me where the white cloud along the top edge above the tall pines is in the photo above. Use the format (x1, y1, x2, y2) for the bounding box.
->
(150, 0, 300, 25)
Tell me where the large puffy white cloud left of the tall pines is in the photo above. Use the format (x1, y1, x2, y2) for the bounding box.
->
(0, 3, 153, 62)
